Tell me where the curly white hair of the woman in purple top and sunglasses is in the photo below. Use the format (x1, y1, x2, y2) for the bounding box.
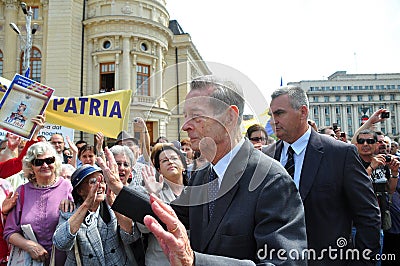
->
(22, 141, 62, 182)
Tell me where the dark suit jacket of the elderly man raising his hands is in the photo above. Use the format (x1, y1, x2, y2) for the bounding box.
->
(113, 140, 307, 265)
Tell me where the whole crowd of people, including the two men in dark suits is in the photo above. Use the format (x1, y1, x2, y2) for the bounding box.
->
(0, 76, 400, 266)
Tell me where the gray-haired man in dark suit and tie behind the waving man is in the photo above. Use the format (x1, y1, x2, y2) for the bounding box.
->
(265, 87, 380, 265)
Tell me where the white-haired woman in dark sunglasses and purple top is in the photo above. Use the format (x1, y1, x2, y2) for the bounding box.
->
(4, 142, 72, 265)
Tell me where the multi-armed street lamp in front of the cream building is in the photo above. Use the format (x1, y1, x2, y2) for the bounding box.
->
(10, 2, 39, 78)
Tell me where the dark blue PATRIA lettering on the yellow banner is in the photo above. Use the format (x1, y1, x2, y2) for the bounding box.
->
(49, 98, 122, 118)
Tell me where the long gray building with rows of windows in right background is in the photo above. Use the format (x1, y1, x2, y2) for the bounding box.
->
(288, 71, 400, 138)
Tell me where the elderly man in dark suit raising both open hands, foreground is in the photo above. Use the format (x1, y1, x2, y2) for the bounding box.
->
(100, 76, 307, 265)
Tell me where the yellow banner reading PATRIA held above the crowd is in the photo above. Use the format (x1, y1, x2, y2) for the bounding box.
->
(0, 78, 132, 138)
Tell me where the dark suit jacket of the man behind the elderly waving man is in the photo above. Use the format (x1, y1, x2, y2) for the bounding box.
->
(266, 130, 380, 265)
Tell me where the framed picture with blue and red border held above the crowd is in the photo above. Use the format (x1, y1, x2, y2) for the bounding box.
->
(0, 74, 54, 139)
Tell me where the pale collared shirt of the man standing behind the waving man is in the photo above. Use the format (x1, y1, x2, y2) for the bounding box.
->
(279, 127, 312, 189)
